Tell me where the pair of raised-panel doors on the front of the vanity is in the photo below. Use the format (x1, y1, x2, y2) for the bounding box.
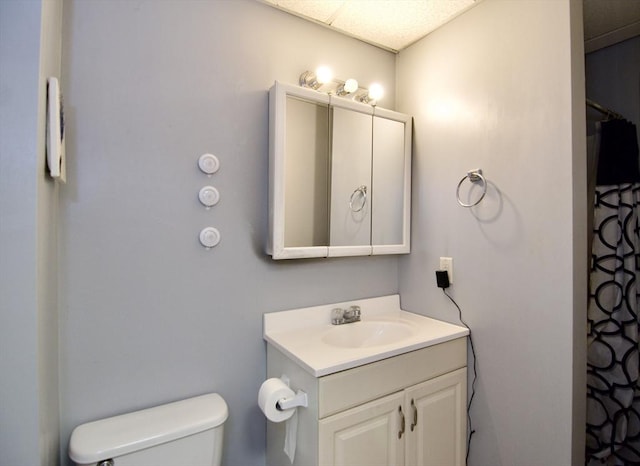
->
(318, 369, 466, 466)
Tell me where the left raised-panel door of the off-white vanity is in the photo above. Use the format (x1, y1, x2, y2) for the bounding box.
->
(318, 393, 406, 466)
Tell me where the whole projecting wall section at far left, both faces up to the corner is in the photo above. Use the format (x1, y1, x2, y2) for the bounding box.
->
(0, 0, 62, 466)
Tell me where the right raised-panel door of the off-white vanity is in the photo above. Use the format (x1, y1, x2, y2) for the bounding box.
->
(405, 368, 467, 466)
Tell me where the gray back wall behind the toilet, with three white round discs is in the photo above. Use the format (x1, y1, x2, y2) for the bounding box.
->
(60, 0, 398, 466)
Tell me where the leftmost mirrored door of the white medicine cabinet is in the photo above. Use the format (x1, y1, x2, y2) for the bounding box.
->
(266, 83, 330, 259)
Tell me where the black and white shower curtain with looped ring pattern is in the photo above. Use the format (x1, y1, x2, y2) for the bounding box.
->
(587, 121, 640, 466)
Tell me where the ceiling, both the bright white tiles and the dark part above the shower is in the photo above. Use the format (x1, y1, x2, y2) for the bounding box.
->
(260, 0, 640, 52)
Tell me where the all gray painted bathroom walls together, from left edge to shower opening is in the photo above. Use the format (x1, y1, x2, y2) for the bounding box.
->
(0, 0, 596, 465)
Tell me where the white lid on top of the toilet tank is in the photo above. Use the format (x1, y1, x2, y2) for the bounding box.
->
(69, 393, 229, 464)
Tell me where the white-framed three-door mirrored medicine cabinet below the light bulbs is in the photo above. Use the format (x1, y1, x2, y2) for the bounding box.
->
(267, 82, 411, 259)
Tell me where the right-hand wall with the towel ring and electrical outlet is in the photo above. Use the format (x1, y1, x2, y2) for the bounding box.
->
(397, 0, 587, 466)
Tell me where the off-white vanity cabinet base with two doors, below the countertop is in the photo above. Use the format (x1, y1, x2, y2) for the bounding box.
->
(267, 337, 467, 466)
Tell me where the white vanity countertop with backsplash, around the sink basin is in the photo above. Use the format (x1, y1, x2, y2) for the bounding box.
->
(264, 295, 469, 377)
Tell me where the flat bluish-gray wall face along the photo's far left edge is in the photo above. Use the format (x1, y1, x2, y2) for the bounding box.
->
(0, 2, 40, 464)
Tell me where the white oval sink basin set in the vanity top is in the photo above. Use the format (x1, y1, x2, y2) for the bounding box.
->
(322, 320, 413, 348)
